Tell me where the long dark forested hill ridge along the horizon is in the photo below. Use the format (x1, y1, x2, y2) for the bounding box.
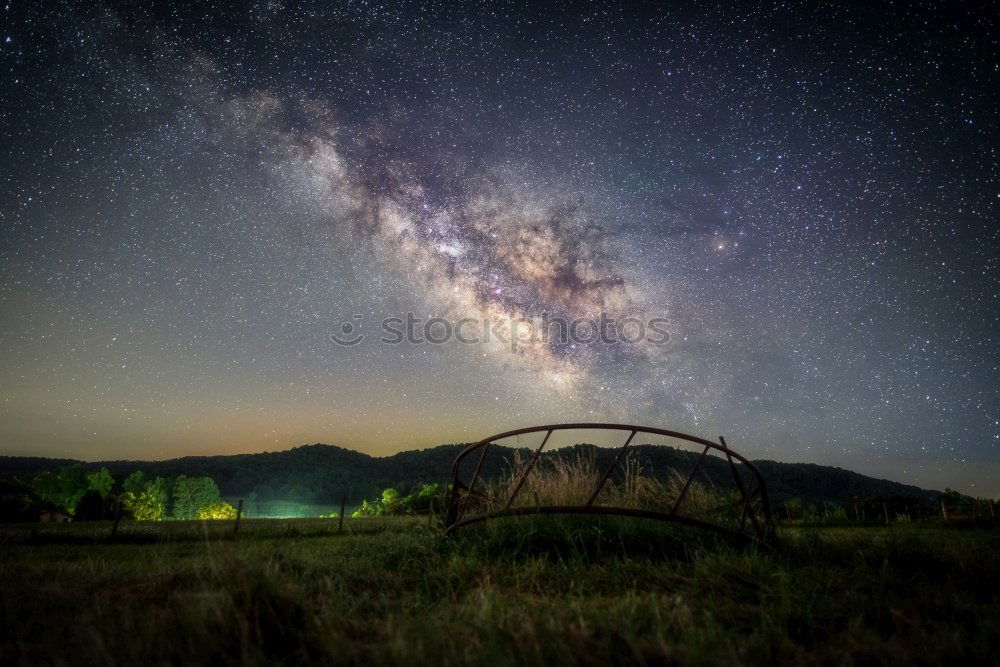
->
(0, 444, 940, 504)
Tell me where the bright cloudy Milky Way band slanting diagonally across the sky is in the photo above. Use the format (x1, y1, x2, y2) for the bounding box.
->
(188, 58, 669, 393)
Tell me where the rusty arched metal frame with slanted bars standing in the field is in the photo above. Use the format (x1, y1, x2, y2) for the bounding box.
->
(444, 423, 774, 545)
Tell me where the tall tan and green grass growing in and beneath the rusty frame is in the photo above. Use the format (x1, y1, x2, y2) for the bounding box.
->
(457, 451, 744, 562)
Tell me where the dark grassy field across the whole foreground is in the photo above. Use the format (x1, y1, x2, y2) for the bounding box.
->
(0, 519, 1000, 665)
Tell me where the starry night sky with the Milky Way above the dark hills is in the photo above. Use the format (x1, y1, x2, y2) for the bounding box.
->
(0, 0, 1000, 495)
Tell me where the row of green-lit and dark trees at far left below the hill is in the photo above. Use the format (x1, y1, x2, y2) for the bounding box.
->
(0, 463, 236, 521)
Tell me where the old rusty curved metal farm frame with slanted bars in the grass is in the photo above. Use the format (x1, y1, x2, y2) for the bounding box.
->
(445, 423, 774, 544)
